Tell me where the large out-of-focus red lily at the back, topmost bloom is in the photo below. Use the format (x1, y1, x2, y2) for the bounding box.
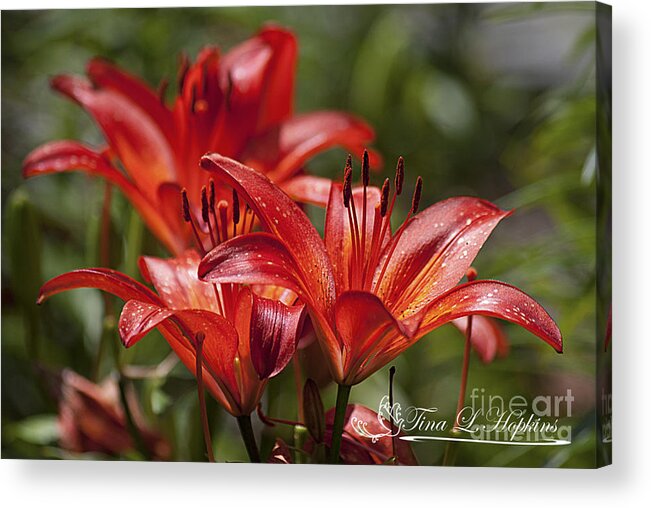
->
(23, 27, 379, 255)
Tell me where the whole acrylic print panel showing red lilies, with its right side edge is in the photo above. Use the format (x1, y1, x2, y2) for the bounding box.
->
(2, 2, 612, 468)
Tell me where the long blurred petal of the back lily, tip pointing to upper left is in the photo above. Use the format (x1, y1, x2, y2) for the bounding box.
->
(51, 76, 176, 202)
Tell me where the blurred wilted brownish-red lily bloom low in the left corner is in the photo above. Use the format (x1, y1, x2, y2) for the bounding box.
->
(58, 370, 171, 460)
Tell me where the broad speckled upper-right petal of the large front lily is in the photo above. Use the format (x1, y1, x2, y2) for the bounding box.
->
(374, 197, 511, 319)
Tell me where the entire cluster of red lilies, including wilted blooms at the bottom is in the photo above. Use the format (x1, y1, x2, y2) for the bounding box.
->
(24, 27, 562, 464)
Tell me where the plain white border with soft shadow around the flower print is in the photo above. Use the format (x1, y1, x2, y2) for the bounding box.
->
(0, 0, 651, 508)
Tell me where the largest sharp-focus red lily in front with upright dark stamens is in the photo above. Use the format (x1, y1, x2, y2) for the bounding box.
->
(199, 154, 562, 386)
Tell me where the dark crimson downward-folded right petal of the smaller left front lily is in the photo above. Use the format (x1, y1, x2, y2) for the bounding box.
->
(250, 294, 305, 379)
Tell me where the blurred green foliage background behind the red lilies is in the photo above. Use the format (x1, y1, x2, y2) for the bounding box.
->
(2, 2, 601, 467)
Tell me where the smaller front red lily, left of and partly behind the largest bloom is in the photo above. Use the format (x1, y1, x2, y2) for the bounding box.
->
(38, 251, 304, 416)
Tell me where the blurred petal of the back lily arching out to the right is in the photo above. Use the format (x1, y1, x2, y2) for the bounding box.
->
(242, 111, 382, 182)
